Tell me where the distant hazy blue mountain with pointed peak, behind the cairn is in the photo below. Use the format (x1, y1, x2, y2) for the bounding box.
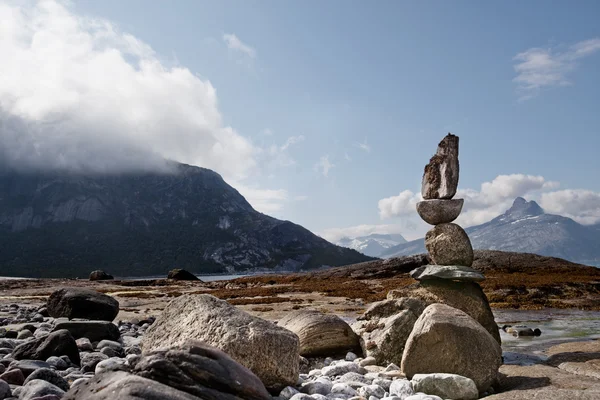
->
(382, 197, 600, 265)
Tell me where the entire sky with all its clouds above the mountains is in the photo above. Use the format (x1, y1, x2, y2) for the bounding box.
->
(0, 0, 600, 241)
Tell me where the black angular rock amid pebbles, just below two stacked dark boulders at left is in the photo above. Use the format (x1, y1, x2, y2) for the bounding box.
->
(12, 329, 80, 364)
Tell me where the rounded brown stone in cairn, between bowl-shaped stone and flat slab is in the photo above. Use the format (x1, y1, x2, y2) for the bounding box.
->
(425, 224, 473, 267)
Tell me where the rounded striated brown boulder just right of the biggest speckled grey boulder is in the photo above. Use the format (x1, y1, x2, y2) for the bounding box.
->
(278, 310, 360, 357)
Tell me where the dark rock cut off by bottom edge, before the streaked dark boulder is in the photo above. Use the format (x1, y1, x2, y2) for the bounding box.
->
(62, 371, 204, 400)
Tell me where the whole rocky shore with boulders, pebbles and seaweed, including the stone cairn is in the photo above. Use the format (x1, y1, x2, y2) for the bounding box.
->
(0, 135, 600, 400)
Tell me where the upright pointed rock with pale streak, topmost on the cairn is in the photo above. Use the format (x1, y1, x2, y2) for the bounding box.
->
(421, 133, 458, 200)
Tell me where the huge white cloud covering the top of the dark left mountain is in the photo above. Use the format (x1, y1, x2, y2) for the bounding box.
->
(0, 1, 259, 180)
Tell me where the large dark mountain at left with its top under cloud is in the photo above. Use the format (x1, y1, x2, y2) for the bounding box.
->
(0, 164, 371, 277)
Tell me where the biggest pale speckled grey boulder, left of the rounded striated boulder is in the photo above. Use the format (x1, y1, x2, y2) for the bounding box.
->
(141, 294, 299, 393)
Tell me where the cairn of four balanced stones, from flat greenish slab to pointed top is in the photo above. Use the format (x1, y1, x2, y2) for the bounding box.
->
(411, 133, 485, 281)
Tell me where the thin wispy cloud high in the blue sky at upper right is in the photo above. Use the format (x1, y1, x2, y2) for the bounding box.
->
(513, 38, 600, 100)
